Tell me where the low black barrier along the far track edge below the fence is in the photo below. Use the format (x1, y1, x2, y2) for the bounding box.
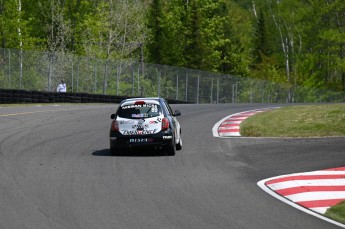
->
(0, 89, 186, 104)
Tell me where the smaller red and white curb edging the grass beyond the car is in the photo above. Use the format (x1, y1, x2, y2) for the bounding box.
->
(212, 107, 278, 137)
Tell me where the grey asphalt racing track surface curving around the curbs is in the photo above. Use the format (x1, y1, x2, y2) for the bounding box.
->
(0, 104, 345, 229)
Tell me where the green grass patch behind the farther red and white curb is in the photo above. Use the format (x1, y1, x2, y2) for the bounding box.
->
(241, 104, 345, 137)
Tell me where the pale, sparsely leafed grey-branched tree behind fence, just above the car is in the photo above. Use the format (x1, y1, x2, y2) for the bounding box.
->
(83, 0, 146, 94)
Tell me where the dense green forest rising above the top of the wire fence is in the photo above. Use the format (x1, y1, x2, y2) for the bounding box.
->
(0, 0, 345, 99)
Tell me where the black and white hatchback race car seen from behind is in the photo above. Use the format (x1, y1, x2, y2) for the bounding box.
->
(109, 98, 182, 155)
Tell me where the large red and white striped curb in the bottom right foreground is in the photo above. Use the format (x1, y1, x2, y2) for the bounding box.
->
(257, 167, 345, 228)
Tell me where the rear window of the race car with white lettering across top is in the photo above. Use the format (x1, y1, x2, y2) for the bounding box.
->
(117, 103, 162, 119)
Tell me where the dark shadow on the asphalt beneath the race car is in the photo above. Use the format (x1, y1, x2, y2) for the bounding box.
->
(92, 149, 169, 157)
